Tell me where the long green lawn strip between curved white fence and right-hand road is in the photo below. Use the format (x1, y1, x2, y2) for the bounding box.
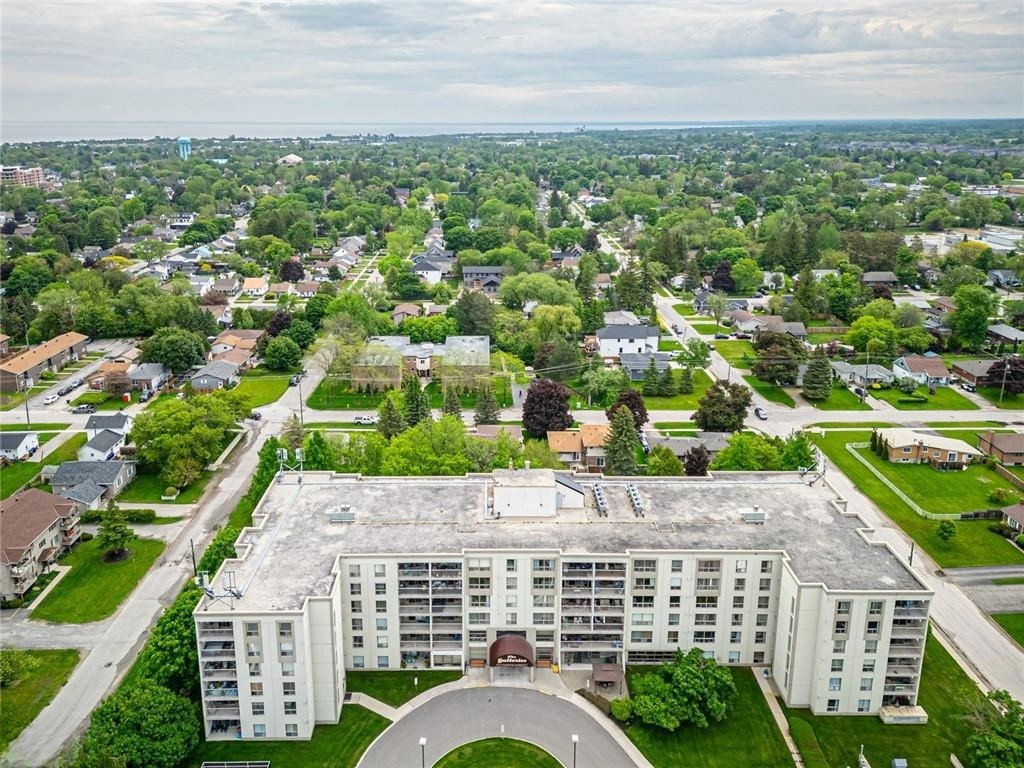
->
(811, 429, 1024, 568)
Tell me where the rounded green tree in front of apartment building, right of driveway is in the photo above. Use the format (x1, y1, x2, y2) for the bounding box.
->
(630, 648, 736, 731)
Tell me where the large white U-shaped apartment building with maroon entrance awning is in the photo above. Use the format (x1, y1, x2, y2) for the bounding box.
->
(195, 469, 931, 739)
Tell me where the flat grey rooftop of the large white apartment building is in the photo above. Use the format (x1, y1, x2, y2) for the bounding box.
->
(202, 470, 926, 611)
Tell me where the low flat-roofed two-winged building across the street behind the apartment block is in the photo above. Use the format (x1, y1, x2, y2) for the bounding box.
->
(352, 336, 490, 390)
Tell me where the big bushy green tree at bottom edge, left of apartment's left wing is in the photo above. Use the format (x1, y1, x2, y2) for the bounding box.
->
(76, 679, 202, 768)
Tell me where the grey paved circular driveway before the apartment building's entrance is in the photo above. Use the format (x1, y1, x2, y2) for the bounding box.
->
(359, 686, 635, 768)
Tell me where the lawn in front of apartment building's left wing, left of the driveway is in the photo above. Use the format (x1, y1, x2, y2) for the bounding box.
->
(183, 705, 391, 768)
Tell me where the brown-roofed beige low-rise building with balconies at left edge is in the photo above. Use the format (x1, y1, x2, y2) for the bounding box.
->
(0, 488, 82, 600)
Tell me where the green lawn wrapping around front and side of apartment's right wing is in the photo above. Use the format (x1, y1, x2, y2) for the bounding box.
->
(779, 636, 994, 768)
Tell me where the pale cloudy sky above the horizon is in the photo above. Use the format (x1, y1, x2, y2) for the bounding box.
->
(0, 0, 1024, 132)
